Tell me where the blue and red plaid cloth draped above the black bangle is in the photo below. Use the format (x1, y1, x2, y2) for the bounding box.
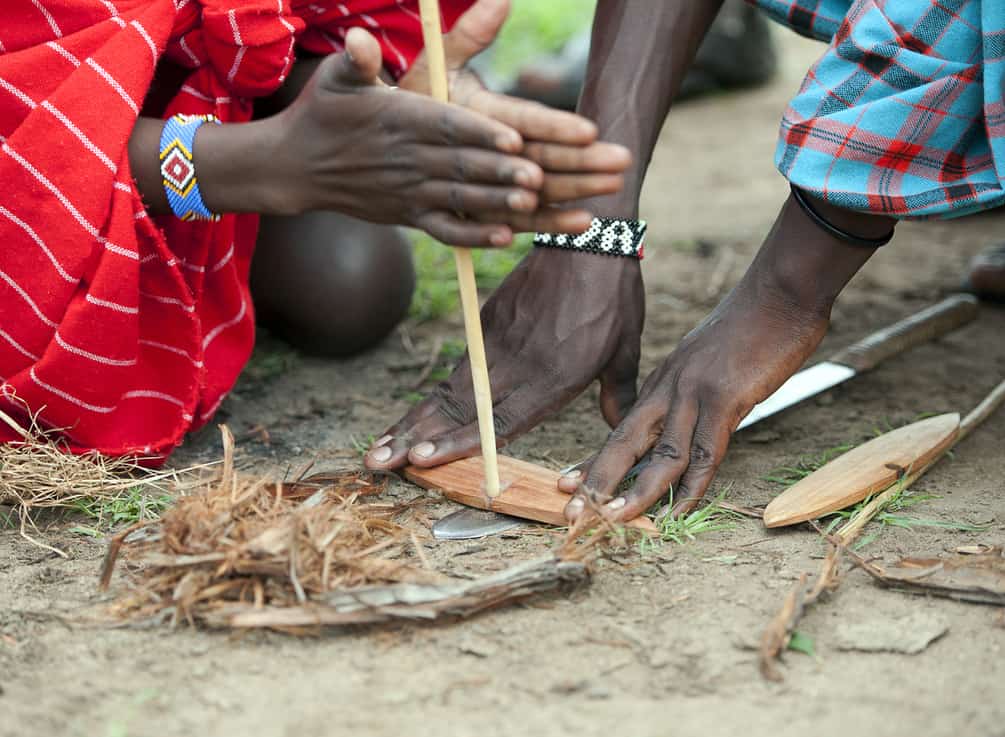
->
(749, 0, 1005, 218)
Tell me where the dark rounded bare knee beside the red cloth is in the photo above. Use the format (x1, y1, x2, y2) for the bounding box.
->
(251, 212, 415, 356)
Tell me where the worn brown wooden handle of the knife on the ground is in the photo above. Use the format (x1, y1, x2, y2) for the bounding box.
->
(830, 295, 977, 373)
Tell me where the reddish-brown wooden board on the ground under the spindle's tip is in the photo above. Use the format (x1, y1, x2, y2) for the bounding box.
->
(405, 455, 656, 533)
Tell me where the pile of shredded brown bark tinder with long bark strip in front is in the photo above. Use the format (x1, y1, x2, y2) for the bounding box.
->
(102, 432, 587, 631)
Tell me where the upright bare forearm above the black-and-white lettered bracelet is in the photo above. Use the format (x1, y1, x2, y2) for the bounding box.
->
(578, 0, 723, 217)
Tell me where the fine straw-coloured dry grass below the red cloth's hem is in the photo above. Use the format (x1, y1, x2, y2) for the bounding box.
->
(0, 397, 185, 555)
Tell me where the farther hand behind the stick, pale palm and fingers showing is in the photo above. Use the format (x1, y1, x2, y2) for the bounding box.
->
(399, 0, 631, 232)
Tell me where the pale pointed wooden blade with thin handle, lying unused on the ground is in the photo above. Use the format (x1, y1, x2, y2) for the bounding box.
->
(764, 381, 1005, 527)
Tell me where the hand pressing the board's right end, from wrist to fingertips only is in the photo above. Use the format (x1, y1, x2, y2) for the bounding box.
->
(559, 273, 828, 520)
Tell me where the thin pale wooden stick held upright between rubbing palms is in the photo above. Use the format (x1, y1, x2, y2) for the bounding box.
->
(419, 0, 499, 499)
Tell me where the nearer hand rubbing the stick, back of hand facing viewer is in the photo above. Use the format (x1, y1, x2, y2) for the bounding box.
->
(262, 28, 543, 246)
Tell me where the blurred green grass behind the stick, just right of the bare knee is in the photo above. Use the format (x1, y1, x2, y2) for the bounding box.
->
(410, 231, 534, 319)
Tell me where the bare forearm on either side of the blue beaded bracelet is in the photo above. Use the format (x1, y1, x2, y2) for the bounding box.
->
(129, 118, 276, 215)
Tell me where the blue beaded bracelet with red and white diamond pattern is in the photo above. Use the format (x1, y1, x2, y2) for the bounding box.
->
(161, 115, 220, 220)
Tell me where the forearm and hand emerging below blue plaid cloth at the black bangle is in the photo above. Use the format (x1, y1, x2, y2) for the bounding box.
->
(559, 193, 891, 520)
